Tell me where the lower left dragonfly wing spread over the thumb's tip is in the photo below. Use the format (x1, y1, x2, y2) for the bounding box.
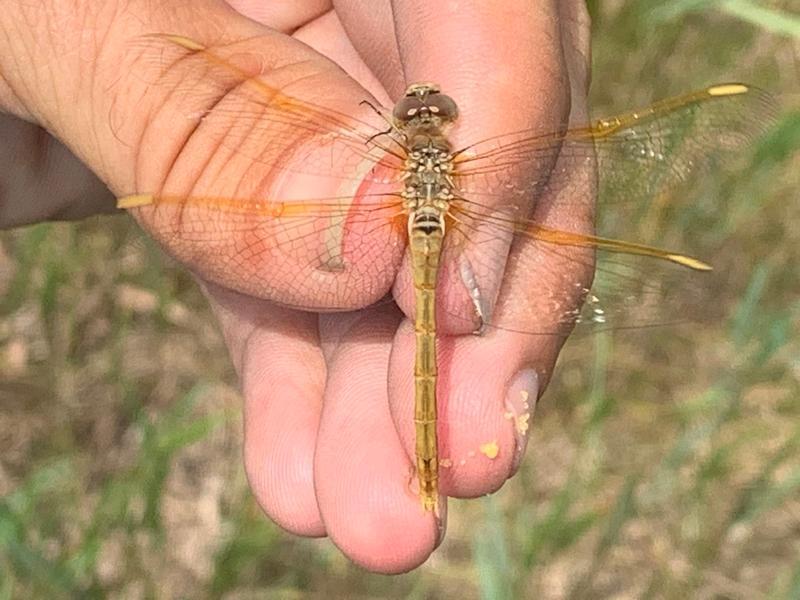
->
(119, 194, 406, 311)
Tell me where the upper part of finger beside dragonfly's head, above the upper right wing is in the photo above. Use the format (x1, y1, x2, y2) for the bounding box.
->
(392, 0, 569, 146)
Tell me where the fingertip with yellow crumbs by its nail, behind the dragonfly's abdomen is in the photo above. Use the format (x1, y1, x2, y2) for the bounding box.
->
(390, 324, 539, 498)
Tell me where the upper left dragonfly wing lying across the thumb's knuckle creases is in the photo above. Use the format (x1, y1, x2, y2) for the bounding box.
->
(119, 34, 403, 183)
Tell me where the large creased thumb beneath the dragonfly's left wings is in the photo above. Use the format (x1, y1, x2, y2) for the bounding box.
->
(0, 0, 402, 308)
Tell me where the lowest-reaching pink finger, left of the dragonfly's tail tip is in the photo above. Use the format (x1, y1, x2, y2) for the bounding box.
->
(315, 311, 440, 573)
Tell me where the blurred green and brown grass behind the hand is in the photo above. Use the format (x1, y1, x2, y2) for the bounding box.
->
(0, 0, 800, 600)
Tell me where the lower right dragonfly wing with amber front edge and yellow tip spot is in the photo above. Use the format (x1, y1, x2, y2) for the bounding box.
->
(418, 204, 722, 336)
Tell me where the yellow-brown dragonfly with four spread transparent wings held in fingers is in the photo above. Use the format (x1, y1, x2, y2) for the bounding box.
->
(118, 34, 774, 511)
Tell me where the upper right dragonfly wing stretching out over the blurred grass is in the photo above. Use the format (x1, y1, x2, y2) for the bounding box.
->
(450, 84, 776, 213)
